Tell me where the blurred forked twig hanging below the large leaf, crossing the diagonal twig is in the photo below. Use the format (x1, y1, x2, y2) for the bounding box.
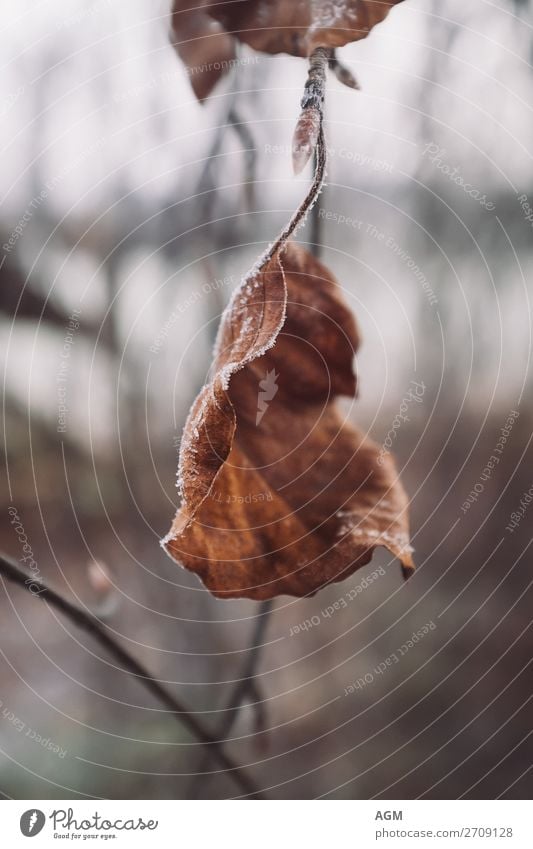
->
(188, 599, 273, 799)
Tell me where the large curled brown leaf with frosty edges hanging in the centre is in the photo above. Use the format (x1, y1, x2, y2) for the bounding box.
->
(163, 242, 414, 599)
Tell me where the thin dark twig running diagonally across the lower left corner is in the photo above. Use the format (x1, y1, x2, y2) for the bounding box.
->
(0, 554, 264, 799)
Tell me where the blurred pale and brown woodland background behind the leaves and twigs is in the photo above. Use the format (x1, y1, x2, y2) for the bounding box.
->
(0, 0, 533, 799)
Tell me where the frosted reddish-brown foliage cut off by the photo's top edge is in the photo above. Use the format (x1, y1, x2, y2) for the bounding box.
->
(172, 0, 402, 99)
